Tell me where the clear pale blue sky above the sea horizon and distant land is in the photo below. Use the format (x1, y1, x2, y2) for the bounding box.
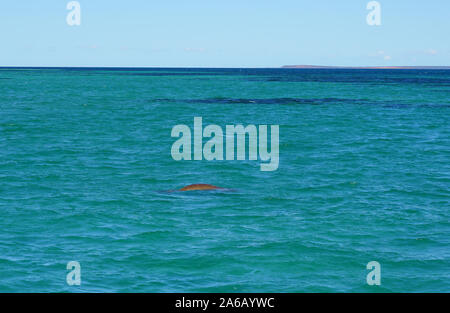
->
(0, 0, 450, 67)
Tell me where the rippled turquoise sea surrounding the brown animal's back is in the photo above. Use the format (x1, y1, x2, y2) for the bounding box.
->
(0, 69, 450, 292)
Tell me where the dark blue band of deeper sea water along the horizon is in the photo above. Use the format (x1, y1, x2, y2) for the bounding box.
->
(0, 67, 450, 87)
